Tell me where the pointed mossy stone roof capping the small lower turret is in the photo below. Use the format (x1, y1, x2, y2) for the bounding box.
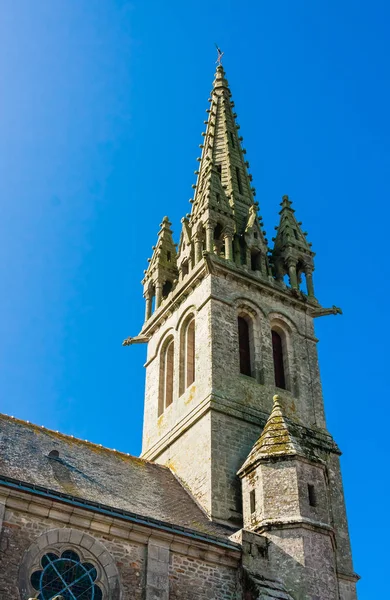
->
(239, 395, 305, 474)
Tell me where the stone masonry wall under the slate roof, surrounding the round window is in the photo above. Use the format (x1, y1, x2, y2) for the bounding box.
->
(0, 497, 240, 600)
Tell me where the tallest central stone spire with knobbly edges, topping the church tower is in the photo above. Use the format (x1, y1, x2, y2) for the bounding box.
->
(180, 65, 269, 277)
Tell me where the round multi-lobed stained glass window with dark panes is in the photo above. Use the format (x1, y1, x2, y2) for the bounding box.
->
(31, 550, 103, 600)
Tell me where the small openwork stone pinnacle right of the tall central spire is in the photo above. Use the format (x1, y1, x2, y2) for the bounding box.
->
(272, 196, 315, 299)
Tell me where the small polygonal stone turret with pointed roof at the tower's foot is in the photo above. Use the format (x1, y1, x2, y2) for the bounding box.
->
(238, 395, 339, 600)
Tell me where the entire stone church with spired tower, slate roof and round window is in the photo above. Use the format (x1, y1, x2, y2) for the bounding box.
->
(0, 66, 357, 600)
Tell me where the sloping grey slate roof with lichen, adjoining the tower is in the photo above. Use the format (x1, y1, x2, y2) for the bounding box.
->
(0, 415, 234, 545)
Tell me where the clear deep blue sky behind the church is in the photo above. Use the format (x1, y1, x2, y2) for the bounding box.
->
(0, 0, 390, 600)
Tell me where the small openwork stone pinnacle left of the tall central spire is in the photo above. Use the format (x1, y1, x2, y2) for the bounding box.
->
(142, 217, 178, 321)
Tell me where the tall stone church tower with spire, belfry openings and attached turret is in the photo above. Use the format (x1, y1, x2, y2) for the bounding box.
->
(125, 65, 356, 600)
